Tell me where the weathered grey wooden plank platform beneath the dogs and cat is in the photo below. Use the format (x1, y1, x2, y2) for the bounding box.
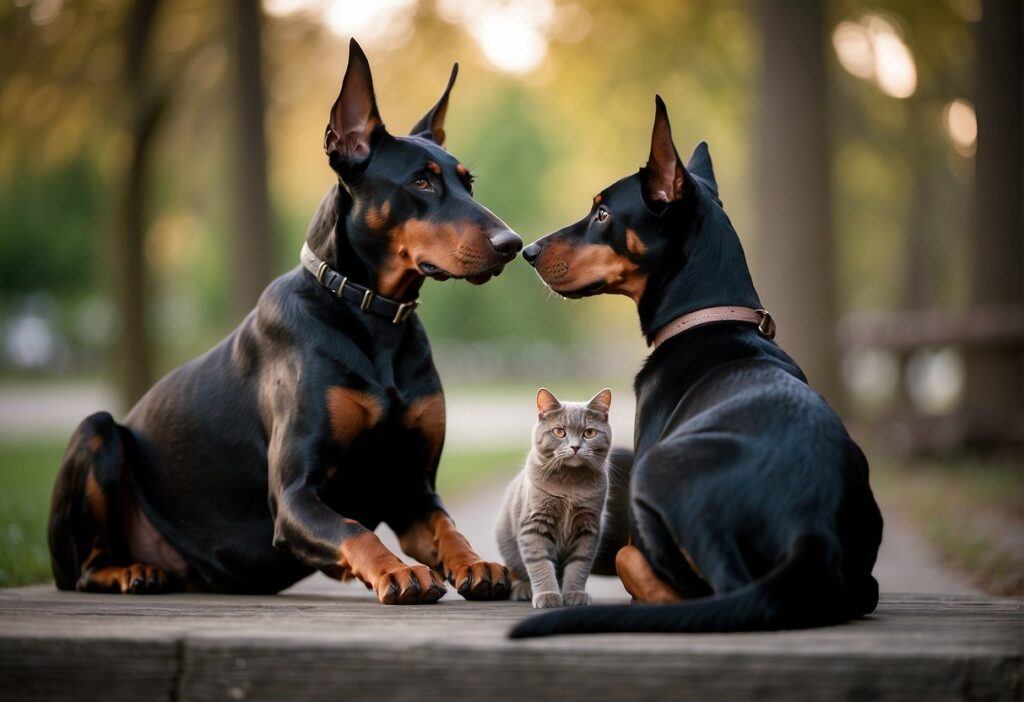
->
(0, 586, 1024, 702)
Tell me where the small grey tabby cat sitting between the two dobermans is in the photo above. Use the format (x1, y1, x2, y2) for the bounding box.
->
(497, 388, 611, 608)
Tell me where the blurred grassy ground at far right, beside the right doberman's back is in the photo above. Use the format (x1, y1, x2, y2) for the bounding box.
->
(871, 459, 1024, 595)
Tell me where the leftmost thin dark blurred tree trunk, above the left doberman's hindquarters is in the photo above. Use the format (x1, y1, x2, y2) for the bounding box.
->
(114, 0, 168, 408)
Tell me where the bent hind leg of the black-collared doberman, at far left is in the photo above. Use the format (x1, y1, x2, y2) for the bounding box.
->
(49, 412, 173, 594)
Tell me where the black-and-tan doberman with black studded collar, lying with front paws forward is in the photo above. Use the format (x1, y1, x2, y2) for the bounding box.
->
(49, 41, 521, 604)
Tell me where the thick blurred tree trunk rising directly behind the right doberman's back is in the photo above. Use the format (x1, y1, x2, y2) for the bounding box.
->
(756, 0, 842, 405)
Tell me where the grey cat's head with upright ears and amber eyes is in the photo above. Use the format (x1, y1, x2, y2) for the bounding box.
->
(534, 388, 611, 468)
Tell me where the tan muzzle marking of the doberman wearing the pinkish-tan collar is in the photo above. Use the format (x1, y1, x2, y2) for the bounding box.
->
(536, 237, 647, 303)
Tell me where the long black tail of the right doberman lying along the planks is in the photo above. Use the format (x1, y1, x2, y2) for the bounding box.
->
(509, 536, 851, 639)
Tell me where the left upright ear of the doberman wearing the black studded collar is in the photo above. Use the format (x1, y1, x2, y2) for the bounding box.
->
(324, 39, 381, 165)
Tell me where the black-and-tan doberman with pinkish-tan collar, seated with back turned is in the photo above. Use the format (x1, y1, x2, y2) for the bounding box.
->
(511, 97, 882, 638)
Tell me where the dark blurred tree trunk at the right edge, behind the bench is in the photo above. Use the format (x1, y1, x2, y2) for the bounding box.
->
(965, 0, 1024, 433)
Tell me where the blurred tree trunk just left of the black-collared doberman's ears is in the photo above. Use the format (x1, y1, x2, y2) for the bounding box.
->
(228, 0, 272, 315)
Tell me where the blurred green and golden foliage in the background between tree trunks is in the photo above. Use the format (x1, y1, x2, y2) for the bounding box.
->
(0, 0, 972, 378)
